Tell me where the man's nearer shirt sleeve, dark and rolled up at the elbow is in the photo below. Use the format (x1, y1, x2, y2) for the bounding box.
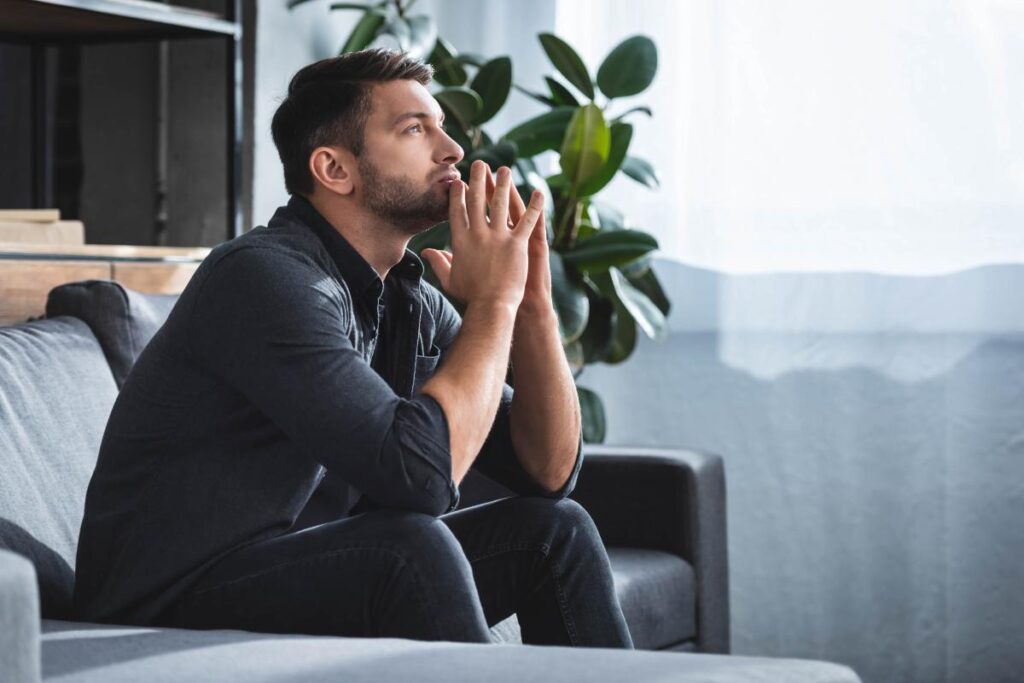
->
(190, 247, 459, 516)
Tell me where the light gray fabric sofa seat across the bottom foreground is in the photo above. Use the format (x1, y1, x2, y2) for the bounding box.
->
(36, 622, 859, 683)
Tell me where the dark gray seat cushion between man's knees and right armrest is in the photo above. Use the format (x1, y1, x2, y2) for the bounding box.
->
(490, 548, 696, 650)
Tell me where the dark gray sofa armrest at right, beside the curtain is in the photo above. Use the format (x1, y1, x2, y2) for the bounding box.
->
(571, 445, 729, 653)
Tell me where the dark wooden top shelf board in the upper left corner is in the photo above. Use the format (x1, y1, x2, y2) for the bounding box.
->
(0, 0, 235, 44)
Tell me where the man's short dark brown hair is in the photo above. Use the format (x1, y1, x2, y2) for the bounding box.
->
(270, 48, 434, 195)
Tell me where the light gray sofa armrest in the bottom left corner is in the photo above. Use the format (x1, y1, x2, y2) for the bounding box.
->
(0, 548, 42, 683)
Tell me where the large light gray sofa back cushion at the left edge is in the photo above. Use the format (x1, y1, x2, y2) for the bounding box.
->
(0, 317, 118, 616)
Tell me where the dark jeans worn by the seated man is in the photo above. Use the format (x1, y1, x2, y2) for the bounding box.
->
(155, 497, 633, 648)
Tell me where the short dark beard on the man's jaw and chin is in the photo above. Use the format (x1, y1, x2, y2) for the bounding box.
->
(358, 158, 449, 234)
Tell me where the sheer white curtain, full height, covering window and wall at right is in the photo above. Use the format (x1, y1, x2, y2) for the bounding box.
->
(553, 0, 1024, 683)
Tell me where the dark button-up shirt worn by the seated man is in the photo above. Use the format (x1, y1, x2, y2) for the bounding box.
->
(75, 196, 583, 624)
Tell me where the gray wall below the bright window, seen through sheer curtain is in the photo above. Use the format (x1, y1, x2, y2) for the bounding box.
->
(579, 259, 1024, 683)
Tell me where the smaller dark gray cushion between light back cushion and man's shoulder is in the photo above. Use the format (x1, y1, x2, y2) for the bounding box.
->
(46, 280, 178, 389)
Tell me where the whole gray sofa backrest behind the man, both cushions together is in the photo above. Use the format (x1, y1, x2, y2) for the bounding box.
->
(0, 280, 177, 618)
